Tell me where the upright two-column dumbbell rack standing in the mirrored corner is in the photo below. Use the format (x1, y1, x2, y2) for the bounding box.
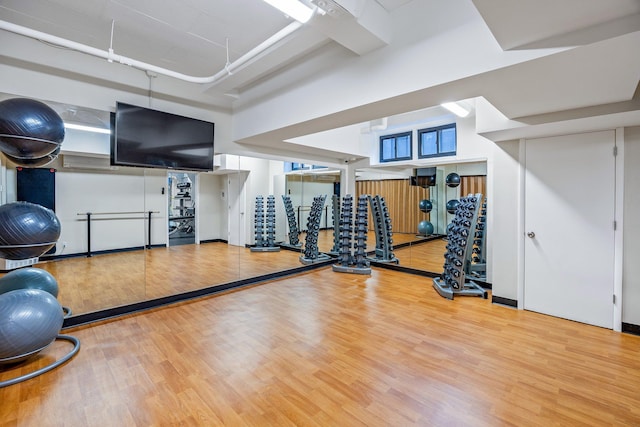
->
(332, 194, 371, 274)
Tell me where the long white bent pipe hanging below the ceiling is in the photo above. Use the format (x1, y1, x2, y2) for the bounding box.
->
(0, 21, 303, 84)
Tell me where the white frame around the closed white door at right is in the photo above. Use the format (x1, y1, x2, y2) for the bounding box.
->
(516, 128, 624, 332)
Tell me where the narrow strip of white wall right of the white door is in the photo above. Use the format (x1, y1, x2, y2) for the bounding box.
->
(622, 127, 640, 325)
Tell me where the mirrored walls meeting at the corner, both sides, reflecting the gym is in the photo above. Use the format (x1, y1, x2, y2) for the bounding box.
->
(0, 91, 487, 324)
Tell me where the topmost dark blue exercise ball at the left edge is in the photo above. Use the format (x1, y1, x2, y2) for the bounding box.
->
(0, 98, 64, 159)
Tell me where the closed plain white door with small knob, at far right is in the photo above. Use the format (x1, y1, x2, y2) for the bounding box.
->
(524, 131, 615, 328)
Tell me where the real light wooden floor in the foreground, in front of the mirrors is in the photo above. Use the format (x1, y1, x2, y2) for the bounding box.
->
(0, 268, 640, 427)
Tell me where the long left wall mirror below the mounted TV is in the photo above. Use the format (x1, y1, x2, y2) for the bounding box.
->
(0, 95, 350, 322)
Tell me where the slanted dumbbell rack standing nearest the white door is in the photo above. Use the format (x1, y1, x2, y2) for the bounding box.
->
(433, 193, 487, 299)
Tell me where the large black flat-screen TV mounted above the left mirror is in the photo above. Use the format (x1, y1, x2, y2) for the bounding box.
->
(111, 102, 214, 171)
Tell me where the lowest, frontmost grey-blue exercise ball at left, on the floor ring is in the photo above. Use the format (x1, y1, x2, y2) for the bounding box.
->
(0, 289, 64, 364)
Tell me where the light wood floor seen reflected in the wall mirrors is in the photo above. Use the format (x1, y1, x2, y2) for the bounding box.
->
(2, 231, 445, 314)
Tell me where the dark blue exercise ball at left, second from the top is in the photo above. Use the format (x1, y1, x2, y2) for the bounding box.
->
(0, 202, 60, 260)
